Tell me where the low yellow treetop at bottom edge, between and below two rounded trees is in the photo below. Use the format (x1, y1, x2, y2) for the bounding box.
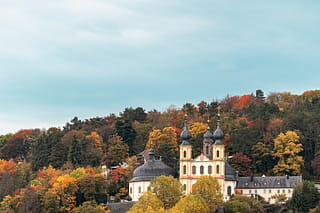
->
(169, 194, 210, 213)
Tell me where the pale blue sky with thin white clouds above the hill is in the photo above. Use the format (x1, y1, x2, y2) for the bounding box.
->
(0, 0, 320, 134)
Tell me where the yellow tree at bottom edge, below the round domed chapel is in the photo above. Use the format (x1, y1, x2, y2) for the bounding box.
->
(128, 190, 164, 213)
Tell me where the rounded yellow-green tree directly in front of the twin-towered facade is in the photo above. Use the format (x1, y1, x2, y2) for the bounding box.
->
(191, 176, 223, 212)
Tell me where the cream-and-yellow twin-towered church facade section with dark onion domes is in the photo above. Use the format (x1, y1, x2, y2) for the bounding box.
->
(179, 113, 238, 201)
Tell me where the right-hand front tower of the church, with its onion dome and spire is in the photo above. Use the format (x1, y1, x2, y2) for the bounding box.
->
(212, 106, 225, 192)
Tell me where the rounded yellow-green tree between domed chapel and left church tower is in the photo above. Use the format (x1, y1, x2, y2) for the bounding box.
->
(148, 176, 182, 209)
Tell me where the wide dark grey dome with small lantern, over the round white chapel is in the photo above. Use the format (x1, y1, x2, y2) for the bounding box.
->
(130, 147, 176, 182)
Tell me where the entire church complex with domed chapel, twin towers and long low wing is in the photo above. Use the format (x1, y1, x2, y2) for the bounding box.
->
(129, 110, 302, 203)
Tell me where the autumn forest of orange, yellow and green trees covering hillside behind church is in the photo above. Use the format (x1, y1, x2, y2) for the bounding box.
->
(0, 90, 320, 212)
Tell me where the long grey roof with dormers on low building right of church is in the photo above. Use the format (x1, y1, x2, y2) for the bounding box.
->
(237, 176, 302, 189)
